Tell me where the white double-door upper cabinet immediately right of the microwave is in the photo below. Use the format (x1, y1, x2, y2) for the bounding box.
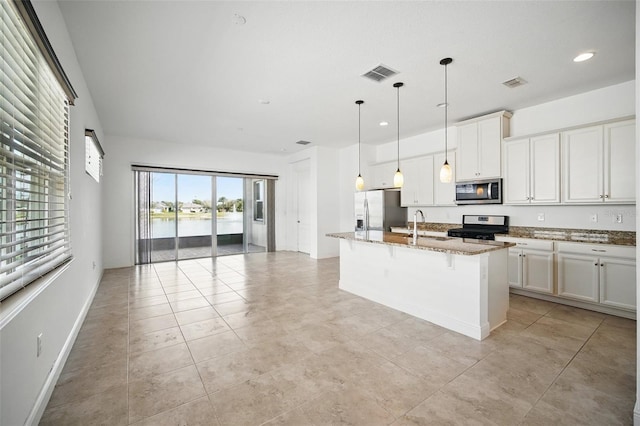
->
(503, 133, 560, 204)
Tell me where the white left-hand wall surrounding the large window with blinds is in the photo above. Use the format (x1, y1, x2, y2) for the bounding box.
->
(0, 1, 105, 425)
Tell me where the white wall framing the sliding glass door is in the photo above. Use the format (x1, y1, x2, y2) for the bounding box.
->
(103, 135, 286, 268)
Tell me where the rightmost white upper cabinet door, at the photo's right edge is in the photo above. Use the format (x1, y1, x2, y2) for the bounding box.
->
(604, 120, 636, 203)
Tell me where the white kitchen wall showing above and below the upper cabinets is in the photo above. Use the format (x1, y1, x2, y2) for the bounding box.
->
(340, 81, 637, 231)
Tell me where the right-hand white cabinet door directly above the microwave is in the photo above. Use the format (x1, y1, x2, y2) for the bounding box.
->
(478, 117, 502, 179)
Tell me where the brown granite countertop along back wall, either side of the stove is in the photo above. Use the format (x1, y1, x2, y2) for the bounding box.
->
(398, 222, 636, 246)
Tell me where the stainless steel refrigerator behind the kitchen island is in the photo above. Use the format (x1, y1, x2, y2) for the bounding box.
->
(354, 189, 407, 231)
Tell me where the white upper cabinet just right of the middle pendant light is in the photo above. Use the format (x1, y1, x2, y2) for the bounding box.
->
(400, 155, 433, 207)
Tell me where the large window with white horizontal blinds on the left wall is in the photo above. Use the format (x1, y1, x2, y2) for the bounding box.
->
(0, 1, 75, 300)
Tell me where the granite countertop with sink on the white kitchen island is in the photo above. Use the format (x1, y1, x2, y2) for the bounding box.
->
(327, 231, 515, 256)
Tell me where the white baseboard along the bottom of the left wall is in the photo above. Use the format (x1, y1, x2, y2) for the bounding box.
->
(24, 270, 104, 426)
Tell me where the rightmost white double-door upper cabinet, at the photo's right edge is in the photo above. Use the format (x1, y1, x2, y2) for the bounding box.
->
(562, 120, 635, 204)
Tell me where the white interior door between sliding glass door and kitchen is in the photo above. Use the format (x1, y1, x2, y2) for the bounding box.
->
(294, 160, 311, 254)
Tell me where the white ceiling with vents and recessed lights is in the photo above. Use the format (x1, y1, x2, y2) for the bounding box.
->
(59, 0, 635, 154)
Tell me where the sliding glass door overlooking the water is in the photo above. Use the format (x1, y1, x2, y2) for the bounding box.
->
(135, 170, 275, 264)
